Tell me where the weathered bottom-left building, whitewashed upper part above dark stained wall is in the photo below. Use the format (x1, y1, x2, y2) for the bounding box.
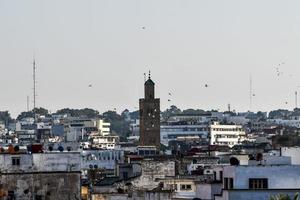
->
(0, 152, 81, 200)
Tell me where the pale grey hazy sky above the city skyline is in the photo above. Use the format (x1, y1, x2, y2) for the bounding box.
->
(0, 0, 300, 116)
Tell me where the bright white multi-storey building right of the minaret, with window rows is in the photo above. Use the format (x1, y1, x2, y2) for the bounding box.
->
(210, 122, 246, 147)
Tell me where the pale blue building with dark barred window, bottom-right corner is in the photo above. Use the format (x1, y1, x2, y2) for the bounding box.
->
(215, 165, 300, 200)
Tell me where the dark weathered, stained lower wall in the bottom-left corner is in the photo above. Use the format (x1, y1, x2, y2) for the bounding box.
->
(0, 172, 80, 200)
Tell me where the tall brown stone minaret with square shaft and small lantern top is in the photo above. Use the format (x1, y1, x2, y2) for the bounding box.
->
(140, 72, 160, 150)
